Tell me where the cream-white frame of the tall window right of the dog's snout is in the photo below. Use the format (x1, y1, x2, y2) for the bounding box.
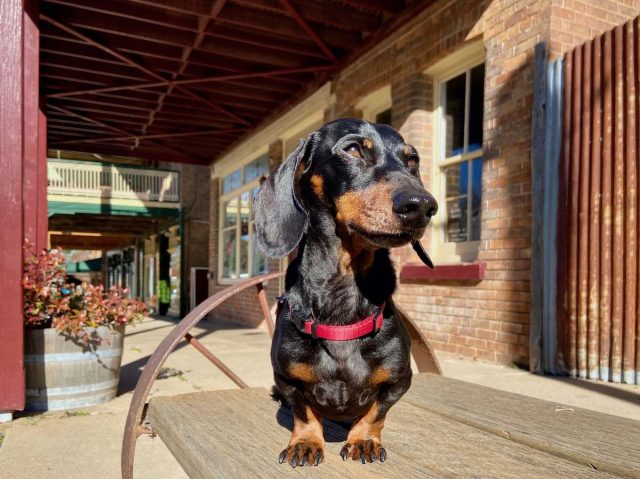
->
(425, 41, 486, 263)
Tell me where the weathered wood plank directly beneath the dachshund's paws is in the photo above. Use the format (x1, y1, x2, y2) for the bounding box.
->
(148, 377, 624, 479)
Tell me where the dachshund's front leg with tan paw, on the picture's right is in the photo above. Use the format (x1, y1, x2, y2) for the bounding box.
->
(340, 371, 411, 464)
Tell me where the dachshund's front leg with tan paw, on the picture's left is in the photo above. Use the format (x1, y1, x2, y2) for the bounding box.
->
(276, 377, 324, 467)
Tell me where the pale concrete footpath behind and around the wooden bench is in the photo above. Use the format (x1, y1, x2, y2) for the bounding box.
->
(0, 319, 640, 479)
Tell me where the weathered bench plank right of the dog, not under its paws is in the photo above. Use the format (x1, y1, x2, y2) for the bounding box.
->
(403, 374, 640, 478)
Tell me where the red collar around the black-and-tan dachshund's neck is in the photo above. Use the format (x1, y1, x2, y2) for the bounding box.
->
(283, 299, 385, 341)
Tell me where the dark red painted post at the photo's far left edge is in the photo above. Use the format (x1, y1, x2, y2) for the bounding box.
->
(0, 0, 25, 411)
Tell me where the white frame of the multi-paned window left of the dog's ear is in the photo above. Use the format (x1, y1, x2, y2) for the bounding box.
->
(218, 148, 268, 284)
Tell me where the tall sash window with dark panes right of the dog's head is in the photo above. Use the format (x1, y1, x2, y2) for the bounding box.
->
(434, 45, 485, 261)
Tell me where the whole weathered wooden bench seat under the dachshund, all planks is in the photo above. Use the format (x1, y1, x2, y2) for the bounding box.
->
(147, 374, 640, 479)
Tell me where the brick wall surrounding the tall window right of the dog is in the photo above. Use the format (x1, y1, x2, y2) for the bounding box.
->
(211, 0, 640, 364)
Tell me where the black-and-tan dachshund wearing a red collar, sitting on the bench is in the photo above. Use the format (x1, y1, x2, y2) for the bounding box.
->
(254, 119, 438, 467)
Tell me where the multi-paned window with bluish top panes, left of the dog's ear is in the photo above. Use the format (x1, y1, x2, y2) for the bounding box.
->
(219, 154, 269, 280)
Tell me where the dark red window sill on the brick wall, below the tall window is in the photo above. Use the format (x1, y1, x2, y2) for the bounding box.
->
(400, 262, 486, 284)
